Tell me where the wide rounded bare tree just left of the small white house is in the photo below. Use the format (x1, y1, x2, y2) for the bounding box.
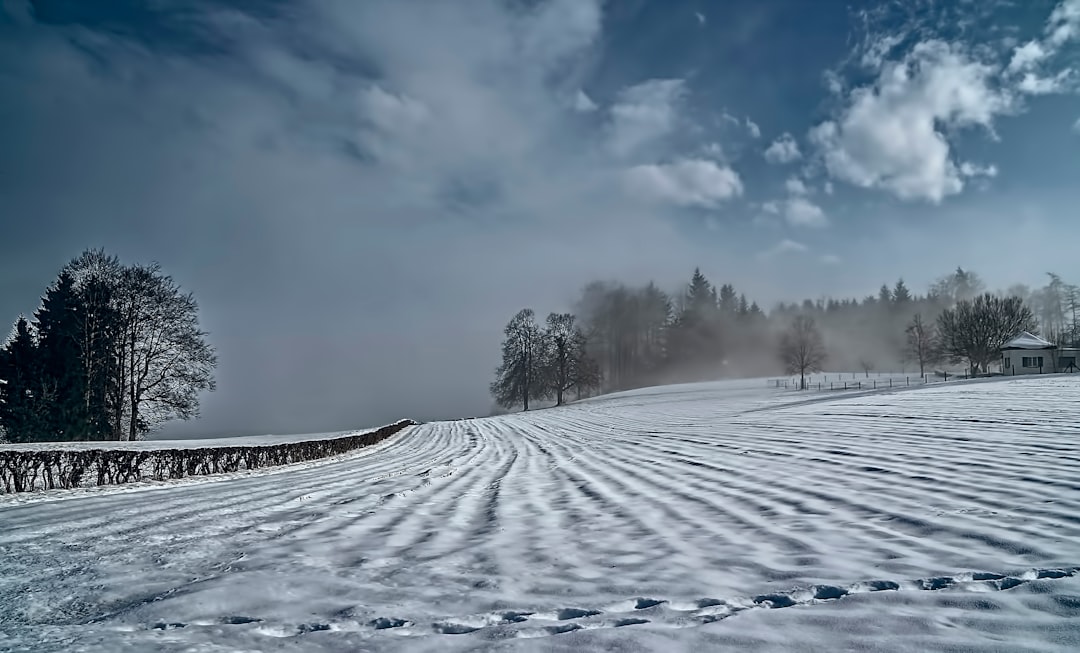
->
(937, 294, 1038, 373)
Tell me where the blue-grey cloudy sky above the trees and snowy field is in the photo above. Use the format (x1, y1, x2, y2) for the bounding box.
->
(0, 0, 1080, 436)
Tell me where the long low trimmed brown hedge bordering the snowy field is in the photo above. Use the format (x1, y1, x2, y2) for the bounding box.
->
(0, 420, 416, 493)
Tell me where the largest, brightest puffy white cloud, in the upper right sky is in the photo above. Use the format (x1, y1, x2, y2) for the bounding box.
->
(810, 41, 1012, 203)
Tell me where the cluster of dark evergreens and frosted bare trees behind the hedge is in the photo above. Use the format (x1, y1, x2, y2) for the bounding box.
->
(0, 250, 217, 443)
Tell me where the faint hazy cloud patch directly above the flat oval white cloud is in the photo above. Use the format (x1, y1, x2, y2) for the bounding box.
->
(608, 79, 686, 155)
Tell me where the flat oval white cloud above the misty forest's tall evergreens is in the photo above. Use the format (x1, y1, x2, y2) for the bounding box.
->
(625, 159, 743, 208)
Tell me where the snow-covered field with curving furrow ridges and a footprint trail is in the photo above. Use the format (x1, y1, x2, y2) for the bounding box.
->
(0, 377, 1080, 652)
